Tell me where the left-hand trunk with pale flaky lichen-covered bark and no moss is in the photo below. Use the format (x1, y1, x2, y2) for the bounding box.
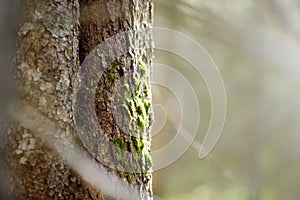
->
(5, 0, 100, 199)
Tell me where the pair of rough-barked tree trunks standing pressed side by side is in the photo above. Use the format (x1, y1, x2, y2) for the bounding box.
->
(5, 0, 153, 199)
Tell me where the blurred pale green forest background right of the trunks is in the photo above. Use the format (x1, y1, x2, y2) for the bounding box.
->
(153, 0, 300, 200)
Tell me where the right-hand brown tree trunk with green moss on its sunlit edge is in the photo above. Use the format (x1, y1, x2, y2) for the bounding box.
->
(80, 0, 153, 199)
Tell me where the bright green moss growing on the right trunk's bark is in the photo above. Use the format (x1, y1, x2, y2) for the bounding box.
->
(102, 57, 152, 171)
